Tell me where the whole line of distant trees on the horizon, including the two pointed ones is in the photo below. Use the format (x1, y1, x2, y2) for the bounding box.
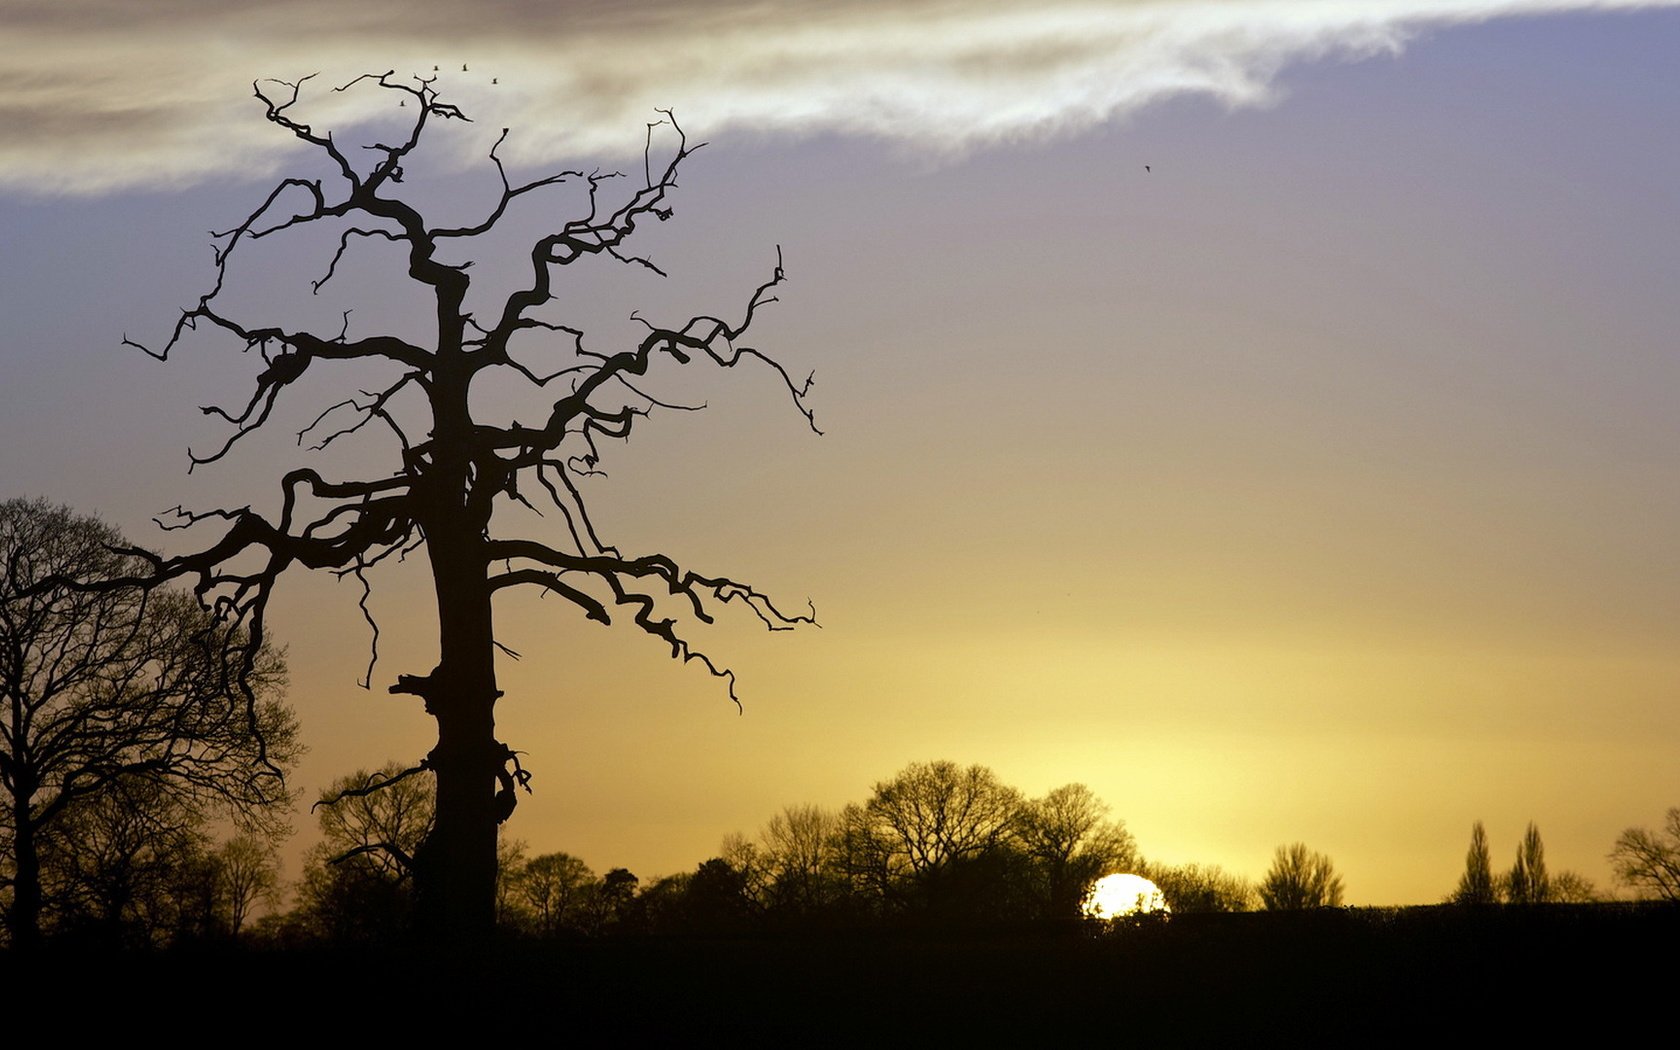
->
(285, 761, 1680, 937)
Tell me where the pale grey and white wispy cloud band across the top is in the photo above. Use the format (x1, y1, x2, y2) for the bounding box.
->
(0, 0, 1680, 193)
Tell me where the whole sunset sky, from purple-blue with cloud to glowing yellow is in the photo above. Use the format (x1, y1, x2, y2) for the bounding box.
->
(0, 0, 1680, 904)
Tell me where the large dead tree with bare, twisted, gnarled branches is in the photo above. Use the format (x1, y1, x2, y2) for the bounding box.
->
(124, 72, 816, 937)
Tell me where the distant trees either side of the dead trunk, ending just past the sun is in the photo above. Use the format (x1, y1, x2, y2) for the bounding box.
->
(284, 761, 1257, 939)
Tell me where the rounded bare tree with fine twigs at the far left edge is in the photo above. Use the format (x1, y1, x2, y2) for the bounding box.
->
(0, 499, 302, 949)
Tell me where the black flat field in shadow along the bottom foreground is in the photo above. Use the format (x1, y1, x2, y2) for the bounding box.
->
(0, 906, 1680, 1047)
